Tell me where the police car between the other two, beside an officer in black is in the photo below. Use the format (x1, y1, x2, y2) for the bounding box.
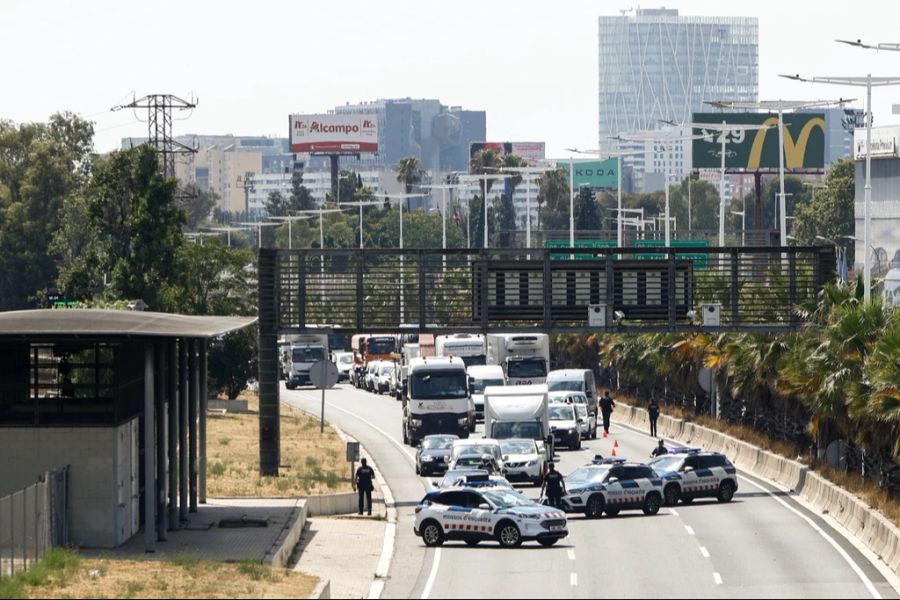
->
(562, 459, 663, 518)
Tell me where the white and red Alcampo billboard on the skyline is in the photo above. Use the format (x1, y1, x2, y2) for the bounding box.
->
(289, 113, 378, 154)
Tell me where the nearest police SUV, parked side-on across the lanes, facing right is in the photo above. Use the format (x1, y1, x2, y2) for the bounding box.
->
(413, 480, 569, 548)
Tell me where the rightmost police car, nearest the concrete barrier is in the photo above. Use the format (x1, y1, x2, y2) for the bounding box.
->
(650, 448, 737, 506)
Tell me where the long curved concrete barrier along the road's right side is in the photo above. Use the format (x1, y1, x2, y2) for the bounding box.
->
(614, 402, 900, 575)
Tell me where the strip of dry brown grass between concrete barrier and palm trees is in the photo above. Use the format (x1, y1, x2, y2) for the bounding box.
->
(621, 395, 900, 527)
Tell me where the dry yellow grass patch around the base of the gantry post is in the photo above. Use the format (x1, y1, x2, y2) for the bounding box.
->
(206, 394, 351, 497)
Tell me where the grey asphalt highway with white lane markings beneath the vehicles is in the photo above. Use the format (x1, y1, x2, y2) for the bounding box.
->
(281, 384, 900, 598)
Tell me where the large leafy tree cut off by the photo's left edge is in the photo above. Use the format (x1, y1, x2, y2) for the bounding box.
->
(0, 113, 94, 310)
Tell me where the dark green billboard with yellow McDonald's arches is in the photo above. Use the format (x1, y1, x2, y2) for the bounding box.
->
(692, 113, 825, 171)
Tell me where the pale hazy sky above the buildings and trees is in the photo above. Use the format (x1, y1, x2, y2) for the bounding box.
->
(0, 0, 900, 156)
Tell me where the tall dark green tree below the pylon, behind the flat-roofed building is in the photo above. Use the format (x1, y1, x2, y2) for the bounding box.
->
(59, 144, 187, 311)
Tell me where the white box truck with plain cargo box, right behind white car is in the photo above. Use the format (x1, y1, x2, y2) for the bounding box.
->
(484, 384, 553, 460)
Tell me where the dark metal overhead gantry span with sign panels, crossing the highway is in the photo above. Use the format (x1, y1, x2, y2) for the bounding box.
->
(260, 246, 836, 333)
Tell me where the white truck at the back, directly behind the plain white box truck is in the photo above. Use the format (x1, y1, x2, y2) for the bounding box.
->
(487, 333, 550, 385)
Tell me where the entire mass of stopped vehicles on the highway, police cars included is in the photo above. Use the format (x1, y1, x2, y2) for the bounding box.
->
(282, 333, 738, 547)
